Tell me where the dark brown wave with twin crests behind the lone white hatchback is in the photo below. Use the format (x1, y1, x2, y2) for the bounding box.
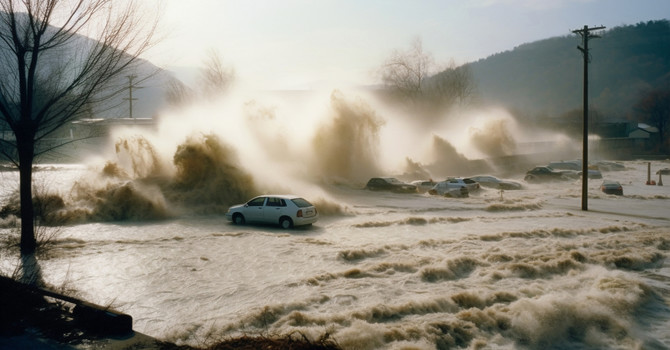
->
(9, 134, 262, 225)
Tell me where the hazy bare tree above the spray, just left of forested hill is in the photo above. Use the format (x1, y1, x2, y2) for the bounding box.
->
(380, 38, 434, 101)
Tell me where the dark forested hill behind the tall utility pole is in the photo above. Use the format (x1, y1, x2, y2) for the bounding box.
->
(470, 20, 670, 119)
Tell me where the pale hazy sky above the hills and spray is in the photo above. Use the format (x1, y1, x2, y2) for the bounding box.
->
(150, 0, 670, 88)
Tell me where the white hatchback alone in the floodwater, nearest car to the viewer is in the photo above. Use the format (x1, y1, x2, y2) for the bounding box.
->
(226, 195, 319, 229)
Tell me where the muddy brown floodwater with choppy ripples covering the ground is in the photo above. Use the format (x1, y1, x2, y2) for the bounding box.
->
(0, 161, 670, 349)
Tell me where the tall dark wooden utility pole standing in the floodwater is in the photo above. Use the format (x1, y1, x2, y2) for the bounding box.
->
(572, 26, 605, 211)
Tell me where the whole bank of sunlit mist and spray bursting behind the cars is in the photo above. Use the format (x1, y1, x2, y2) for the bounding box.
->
(13, 83, 588, 222)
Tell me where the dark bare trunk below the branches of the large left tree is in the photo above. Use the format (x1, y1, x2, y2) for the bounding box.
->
(17, 139, 37, 255)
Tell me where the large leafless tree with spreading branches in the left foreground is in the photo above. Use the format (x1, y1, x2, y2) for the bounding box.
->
(0, 0, 157, 254)
